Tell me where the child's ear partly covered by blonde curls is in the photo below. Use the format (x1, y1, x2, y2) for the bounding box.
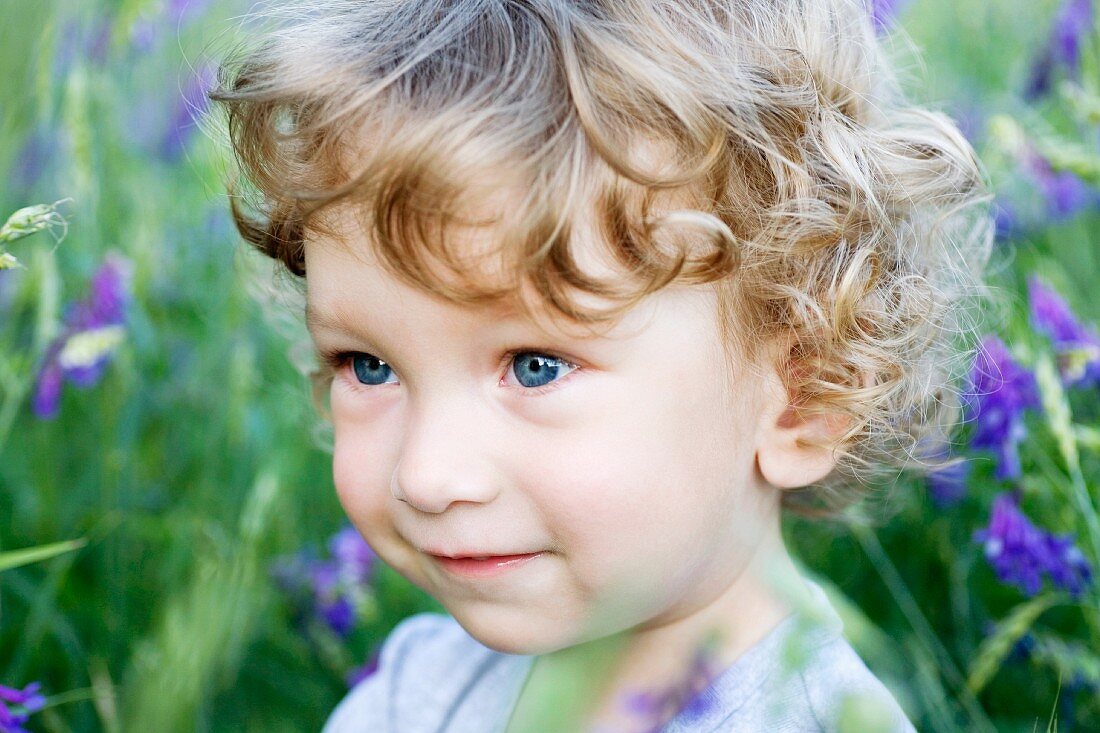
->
(756, 347, 850, 489)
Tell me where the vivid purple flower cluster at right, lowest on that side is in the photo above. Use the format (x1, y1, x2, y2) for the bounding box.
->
(974, 492, 1092, 595)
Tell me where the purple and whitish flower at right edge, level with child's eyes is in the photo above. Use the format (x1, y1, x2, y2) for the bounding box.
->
(1027, 275, 1100, 386)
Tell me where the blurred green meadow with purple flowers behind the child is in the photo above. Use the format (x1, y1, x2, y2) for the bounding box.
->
(0, 0, 1100, 733)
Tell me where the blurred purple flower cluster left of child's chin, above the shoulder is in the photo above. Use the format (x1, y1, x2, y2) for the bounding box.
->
(272, 526, 377, 636)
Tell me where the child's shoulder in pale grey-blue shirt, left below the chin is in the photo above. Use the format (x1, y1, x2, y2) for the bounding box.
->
(323, 613, 525, 733)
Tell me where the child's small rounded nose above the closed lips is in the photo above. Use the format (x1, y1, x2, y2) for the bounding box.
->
(389, 401, 502, 514)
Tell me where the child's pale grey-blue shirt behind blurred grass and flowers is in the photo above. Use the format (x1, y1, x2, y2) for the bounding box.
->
(323, 580, 915, 733)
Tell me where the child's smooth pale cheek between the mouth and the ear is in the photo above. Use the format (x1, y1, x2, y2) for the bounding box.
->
(540, 370, 752, 561)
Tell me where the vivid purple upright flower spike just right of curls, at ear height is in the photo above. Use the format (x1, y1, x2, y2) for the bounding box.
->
(966, 336, 1040, 479)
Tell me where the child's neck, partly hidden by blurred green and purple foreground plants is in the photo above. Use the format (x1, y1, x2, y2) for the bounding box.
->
(508, 526, 805, 733)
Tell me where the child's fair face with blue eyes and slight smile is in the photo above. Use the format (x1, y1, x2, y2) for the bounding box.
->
(306, 215, 779, 654)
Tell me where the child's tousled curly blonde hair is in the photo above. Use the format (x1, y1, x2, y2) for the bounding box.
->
(211, 0, 992, 515)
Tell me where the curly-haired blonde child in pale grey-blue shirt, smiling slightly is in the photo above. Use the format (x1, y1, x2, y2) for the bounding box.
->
(207, 0, 990, 733)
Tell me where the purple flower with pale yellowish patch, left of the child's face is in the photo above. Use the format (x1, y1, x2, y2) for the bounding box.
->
(33, 254, 132, 419)
